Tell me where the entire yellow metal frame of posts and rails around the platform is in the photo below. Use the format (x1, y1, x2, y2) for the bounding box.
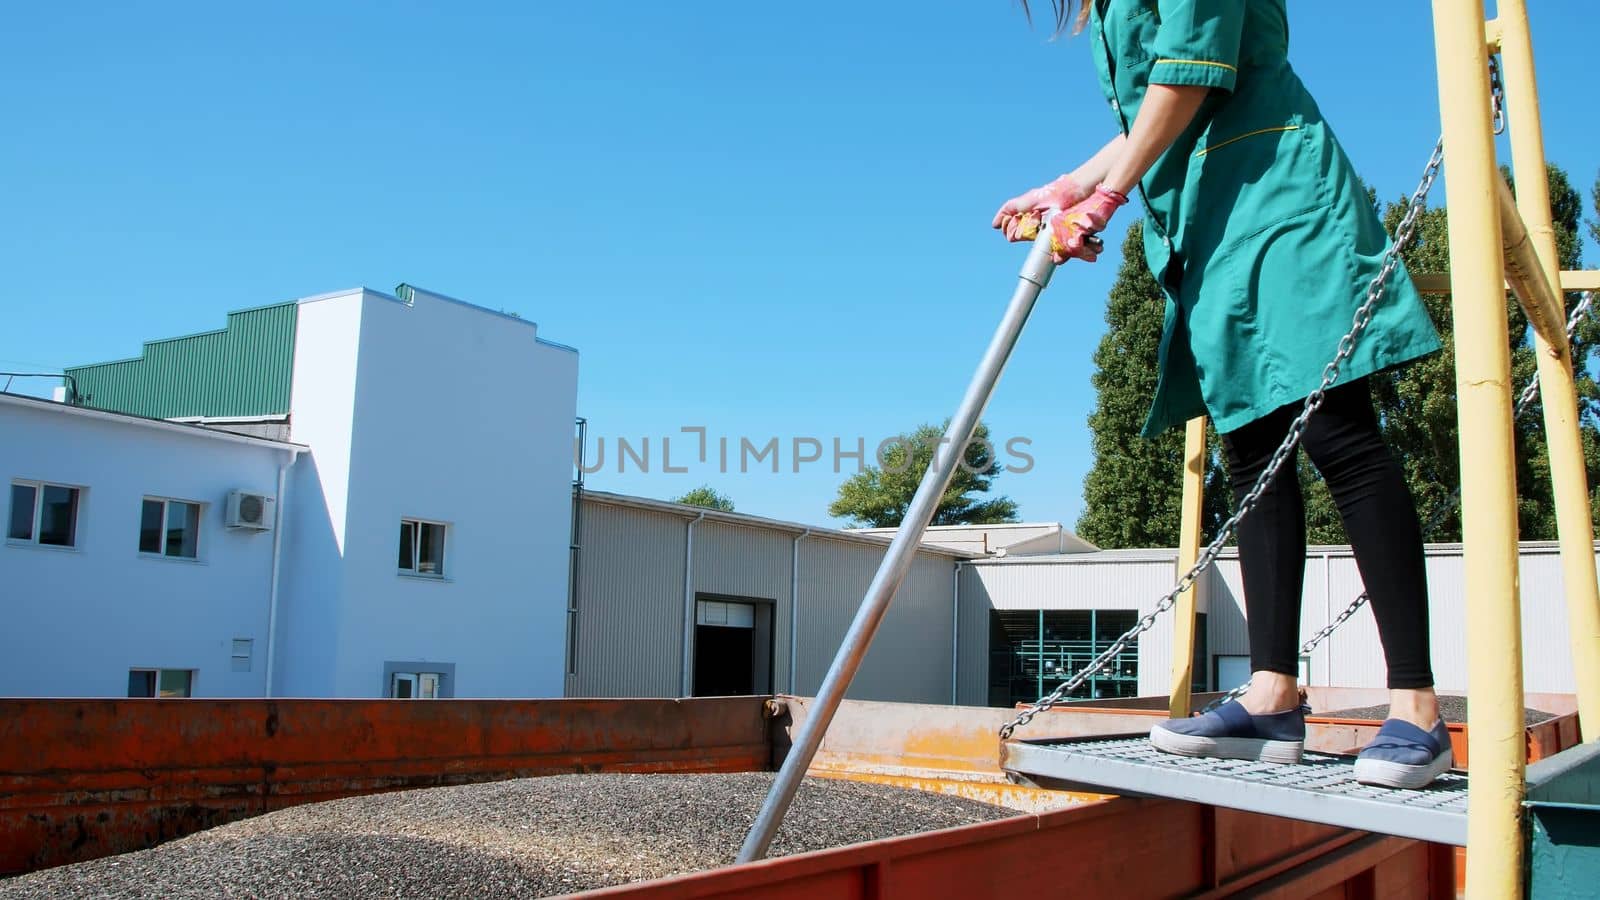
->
(1170, 0, 1600, 900)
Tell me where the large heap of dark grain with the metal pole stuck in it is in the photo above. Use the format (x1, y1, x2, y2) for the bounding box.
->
(0, 772, 1016, 900)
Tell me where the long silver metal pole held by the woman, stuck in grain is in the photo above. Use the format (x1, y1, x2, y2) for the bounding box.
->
(738, 229, 1056, 863)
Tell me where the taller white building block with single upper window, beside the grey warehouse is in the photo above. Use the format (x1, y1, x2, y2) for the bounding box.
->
(280, 290, 578, 697)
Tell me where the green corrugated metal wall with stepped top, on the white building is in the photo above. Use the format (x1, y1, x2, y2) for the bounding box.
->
(66, 303, 298, 418)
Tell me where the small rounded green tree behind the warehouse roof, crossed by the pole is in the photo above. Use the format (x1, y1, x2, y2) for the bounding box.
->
(827, 423, 1018, 528)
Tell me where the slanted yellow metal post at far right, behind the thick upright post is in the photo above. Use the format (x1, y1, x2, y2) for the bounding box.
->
(1499, 0, 1600, 740)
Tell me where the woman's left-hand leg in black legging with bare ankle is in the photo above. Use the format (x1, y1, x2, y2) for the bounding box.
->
(1222, 404, 1306, 716)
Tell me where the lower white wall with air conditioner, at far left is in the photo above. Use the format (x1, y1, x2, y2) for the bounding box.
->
(0, 400, 293, 697)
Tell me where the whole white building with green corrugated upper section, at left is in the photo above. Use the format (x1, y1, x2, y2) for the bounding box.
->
(0, 287, 578, 697)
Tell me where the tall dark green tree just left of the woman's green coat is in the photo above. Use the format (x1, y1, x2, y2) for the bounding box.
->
(1077, 223, 1229, 548)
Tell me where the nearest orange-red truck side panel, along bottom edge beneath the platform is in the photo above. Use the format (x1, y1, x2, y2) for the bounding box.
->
(563, 798, 1454, 900)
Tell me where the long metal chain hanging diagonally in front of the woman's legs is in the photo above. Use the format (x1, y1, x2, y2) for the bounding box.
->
(1000, 138, 1445, 740)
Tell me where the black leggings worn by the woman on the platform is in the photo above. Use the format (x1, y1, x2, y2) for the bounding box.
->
(1222, 378, 1434, 689)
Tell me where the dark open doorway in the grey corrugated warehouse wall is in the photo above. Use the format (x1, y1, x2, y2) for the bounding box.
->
(693, 594, 773, 697)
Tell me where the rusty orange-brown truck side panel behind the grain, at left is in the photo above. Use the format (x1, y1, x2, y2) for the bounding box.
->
(0, 697, 771, 874)
